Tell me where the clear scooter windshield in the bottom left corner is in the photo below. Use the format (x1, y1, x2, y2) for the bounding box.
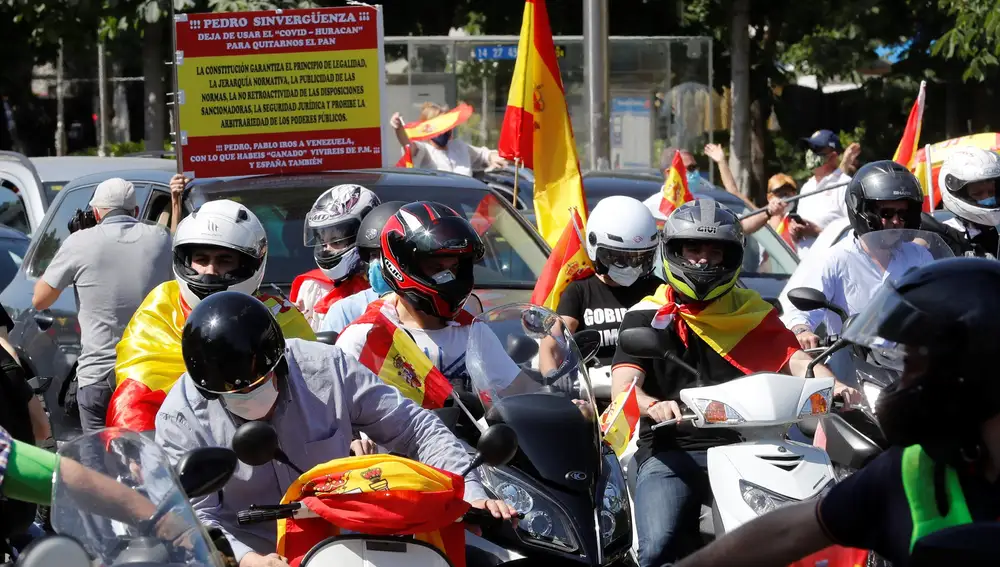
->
(52, 429, 222, 567)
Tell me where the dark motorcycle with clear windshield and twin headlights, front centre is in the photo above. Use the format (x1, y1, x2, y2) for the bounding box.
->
(466, 304, 634, 565)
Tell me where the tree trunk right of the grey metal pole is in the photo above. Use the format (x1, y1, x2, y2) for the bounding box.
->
(729, 0, 750, 195)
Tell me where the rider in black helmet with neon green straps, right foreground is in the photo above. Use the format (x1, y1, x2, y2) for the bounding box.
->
(682, 258, 1000, 567)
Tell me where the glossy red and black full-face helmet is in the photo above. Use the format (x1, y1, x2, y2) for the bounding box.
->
(382, 201, 486, 319)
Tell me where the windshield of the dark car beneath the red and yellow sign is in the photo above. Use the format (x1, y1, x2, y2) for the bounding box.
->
(194, 179, 547, 289)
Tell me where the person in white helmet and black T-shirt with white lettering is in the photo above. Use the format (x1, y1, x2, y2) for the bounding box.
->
(557, 196, 663, 364)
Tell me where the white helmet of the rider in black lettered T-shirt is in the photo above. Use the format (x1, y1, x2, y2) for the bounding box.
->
(586, 196, 660, 287)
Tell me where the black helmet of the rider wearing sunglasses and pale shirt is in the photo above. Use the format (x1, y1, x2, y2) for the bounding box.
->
(847, 160, 924, 236)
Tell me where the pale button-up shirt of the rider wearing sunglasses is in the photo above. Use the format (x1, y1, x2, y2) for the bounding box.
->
(781, 237, 934, 334)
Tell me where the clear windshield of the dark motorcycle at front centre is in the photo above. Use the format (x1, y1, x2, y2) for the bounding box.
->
(466, 303, 597, 423)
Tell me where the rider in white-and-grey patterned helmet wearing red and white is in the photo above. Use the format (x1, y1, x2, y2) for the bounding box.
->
(291, 184, 379, 331)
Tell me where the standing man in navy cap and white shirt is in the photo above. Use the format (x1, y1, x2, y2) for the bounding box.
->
(789, 130, 851, 256)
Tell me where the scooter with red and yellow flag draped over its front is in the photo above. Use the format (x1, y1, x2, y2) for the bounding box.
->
(233, 421, 518, 567)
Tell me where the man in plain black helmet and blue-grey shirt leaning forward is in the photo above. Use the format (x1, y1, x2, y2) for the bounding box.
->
(156, 292, 509, 567)
